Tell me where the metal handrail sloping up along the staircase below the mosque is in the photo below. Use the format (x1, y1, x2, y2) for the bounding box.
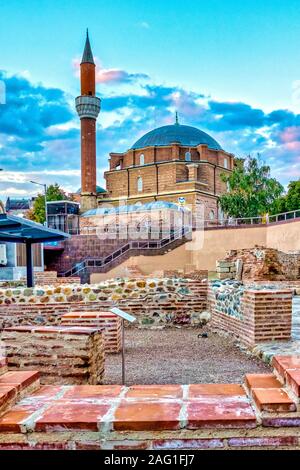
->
(59, 228, 192, 277)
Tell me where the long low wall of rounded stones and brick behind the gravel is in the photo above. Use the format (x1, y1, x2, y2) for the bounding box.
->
(0, 278, 207, 328)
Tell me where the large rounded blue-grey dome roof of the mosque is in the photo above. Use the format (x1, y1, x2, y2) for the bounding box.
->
(131, 122, 222, 150)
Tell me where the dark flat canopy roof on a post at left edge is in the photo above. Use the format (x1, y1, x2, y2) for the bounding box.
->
(0, 214, 69, 243)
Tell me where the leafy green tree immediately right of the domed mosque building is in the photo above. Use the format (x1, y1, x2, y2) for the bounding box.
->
(220, 155, 284, 218)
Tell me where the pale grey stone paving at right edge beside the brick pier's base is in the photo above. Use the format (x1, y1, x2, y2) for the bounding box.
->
(253, 296, 300, 362)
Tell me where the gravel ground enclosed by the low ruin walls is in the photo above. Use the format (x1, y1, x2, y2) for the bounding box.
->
(105, 328, 270, 385)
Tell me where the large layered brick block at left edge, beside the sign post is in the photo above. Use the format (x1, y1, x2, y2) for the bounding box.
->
(0, 326, 104, 385)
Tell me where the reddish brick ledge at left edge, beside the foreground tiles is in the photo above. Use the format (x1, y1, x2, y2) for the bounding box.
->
(0, 371, 40, 415)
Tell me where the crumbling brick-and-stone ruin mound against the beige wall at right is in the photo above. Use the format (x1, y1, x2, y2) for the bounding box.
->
(217, 246, 300, 286)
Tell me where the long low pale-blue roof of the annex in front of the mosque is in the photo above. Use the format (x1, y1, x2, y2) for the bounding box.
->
(82, 201, 188, 217)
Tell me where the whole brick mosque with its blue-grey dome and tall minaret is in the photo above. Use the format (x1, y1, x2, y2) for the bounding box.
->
(76, 33, 234, 220)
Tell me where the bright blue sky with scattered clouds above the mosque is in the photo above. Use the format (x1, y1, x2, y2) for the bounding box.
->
(0, 0, 300, 200)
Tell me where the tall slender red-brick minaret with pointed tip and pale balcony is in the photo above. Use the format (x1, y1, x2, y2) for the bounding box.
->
(75, 31, 101, 212)
